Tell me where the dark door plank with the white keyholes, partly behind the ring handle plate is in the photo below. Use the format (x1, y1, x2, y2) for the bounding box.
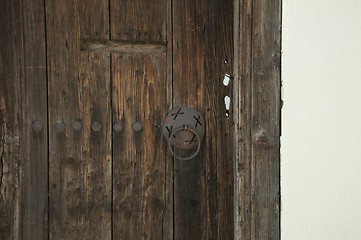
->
(173, 0, 233, 239)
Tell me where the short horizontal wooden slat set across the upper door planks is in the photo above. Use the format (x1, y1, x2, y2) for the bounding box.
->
(80, 39, 167, 54)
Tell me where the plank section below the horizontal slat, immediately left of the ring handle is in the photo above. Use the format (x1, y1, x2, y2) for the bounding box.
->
(112, 54, 172, 239)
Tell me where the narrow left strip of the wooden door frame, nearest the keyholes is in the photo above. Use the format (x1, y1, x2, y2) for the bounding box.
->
(235, 0, 253, 240)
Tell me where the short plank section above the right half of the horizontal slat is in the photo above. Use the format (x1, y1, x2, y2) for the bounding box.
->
(110, 0, 168, 42)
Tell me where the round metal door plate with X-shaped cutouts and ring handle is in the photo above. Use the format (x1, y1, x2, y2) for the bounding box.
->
(163, 107, 205, 160)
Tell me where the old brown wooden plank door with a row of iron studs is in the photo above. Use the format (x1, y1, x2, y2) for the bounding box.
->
(0, 0, 234, 240)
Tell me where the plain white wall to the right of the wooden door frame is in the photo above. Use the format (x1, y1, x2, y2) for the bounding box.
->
(281, 0, 361, 240)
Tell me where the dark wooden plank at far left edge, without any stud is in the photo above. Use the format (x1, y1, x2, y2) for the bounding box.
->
(0, 0, 24, 240)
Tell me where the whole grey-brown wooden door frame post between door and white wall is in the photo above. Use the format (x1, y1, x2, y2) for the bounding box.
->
(233, 0, 282, 240)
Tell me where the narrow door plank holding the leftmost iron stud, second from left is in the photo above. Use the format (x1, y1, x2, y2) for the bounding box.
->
(22, 0, 48, 240)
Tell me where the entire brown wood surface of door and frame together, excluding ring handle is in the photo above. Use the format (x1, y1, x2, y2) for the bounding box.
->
(0, 0, 281, 240)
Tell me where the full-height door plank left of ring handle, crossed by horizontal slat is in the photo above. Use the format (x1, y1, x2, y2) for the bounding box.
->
(110, 0, 173, 239)
